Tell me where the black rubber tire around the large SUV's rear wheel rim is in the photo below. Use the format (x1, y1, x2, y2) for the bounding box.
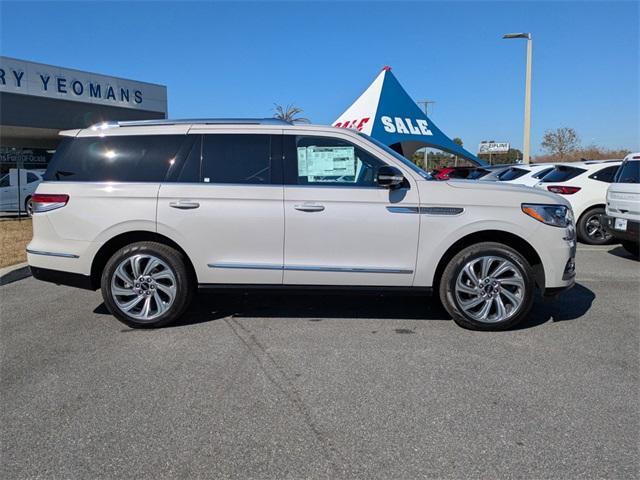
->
(100, 242, 194, 328)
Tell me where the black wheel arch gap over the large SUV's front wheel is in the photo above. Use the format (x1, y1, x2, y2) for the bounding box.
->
(433, 230, 545, 291)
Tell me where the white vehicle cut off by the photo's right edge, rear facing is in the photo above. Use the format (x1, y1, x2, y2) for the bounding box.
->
(602, 152, 640, 257)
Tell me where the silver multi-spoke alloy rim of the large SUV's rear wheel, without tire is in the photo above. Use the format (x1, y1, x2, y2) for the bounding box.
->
(111, 253, 177, 322)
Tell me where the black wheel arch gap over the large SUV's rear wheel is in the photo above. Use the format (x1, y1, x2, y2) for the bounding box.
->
(90, 230, 197, 289)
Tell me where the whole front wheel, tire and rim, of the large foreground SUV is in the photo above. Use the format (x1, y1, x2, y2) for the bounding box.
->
(440, 242, 535, 330)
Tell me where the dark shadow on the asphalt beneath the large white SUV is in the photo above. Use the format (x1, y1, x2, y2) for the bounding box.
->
(94, 284, 595, 330)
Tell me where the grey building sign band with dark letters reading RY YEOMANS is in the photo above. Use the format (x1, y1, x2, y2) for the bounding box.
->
(0, 57, 167, 113)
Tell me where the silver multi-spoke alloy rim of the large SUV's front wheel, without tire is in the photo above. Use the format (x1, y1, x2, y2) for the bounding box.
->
(455, 256, 525, 323)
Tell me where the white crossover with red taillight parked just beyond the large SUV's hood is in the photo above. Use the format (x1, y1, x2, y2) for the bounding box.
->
(536, 160, 622, 245)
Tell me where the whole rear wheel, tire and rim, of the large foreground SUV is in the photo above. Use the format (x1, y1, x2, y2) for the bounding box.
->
(101, 242, 193, 328)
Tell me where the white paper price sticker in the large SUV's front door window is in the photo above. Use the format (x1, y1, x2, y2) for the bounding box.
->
(298, 145, 356, 181)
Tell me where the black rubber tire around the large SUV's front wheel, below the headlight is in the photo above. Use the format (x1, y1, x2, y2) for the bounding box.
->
(439, 242, 535, 331)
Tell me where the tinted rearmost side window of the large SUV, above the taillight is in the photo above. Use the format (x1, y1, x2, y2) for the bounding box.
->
(44, 135, 186, 182)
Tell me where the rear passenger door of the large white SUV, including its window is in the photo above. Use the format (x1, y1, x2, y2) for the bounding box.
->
(158, 129, 284, 284)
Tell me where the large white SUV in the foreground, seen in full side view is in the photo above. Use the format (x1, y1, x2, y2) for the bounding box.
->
(27, 119, 575, 330)
